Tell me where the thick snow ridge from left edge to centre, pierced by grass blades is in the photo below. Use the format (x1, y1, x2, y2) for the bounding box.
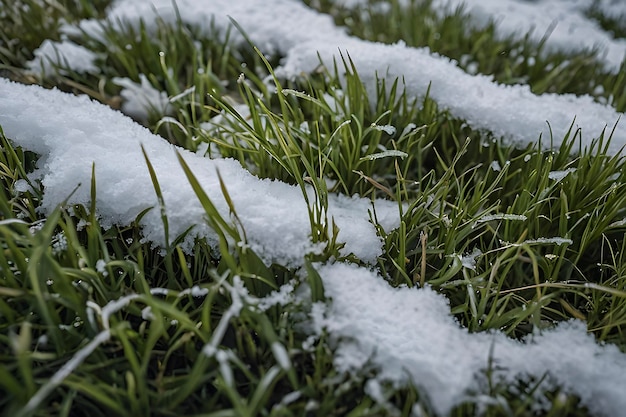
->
(0, 78, 399, 266)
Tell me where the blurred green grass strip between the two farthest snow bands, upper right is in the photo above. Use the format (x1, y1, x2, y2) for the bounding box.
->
(308, 0, 626, 112)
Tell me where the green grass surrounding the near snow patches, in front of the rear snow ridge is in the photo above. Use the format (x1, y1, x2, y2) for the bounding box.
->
(0, 0, 626, 417)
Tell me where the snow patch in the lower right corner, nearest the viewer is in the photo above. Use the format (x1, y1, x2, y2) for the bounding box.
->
(312, 263, 626, 416)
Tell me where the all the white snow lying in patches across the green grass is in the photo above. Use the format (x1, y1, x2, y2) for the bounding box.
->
(0, 0, 626, 416)
